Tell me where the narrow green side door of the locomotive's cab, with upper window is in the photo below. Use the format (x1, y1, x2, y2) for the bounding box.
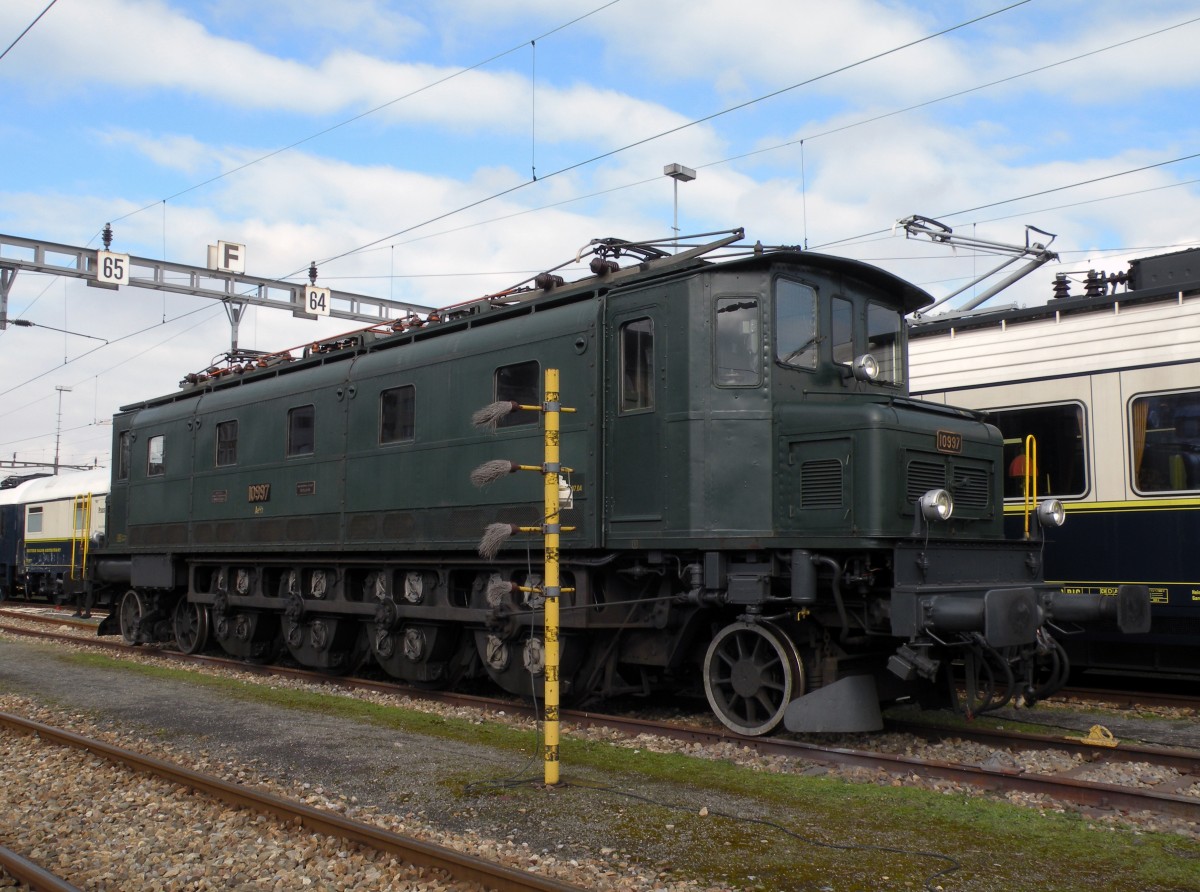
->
(605, 295, 668, 538)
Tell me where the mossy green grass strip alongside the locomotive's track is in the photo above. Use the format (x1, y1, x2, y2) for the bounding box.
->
(65, 654, 1200, 892)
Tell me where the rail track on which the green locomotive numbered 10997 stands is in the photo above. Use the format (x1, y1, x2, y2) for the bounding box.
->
(0, 611, 1200, 824)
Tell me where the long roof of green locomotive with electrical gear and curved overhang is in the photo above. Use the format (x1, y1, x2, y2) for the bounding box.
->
(121, 229, 934, 412)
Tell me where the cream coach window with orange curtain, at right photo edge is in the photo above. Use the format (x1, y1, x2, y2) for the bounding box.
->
(1129, 390, 1200, 493)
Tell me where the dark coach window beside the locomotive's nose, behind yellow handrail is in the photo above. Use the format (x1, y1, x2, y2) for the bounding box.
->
(988, 402, 1087, 498)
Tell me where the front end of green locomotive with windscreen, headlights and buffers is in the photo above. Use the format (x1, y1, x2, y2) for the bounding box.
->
(744, 250, 1148, 731)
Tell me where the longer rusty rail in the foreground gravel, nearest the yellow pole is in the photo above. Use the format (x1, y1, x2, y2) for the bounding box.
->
(0, 712, 581, 892)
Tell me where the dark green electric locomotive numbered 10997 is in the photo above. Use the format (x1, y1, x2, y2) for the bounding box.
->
(95, 231, 1148, 735)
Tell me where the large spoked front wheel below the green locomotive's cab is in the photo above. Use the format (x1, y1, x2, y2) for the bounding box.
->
(704, 623, 804, 737)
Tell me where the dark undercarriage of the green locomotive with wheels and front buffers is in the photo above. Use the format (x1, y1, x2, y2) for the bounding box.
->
(102, 550, 1137, 735)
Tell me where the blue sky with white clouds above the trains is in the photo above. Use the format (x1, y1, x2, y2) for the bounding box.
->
(0, 0, 1200, 463)
